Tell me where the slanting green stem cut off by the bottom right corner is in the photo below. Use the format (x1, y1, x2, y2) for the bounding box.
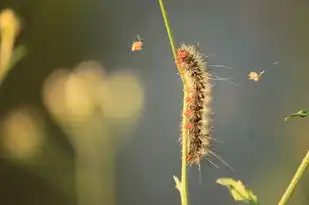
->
(278, 151, 309, 205)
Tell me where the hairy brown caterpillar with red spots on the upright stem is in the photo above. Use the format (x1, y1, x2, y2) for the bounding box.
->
(176, 44, 212, 165)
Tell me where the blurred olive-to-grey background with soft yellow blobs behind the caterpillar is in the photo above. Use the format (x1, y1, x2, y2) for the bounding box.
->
(0, 0, 309, 205)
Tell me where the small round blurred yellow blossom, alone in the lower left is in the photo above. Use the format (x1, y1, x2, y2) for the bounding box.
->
(0, 106, 46, 162)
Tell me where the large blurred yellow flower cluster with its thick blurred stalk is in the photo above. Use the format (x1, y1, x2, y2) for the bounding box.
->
(43, 61, 144, 205)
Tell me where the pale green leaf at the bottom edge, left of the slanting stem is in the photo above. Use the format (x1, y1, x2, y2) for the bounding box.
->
(217, 178, 259, 205)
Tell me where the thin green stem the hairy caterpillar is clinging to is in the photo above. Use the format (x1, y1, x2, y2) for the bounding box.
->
(159, 0, 189, 205)
